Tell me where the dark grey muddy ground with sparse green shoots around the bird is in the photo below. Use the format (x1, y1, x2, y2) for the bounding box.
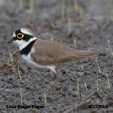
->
(0, 0, 113, 113)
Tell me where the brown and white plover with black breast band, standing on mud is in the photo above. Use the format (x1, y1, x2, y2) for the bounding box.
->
(9, 28, 105, 90)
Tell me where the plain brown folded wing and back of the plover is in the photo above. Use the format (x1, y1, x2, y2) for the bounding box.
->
(31, 39, 103, 65)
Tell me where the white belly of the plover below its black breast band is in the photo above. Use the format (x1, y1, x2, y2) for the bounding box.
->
(22, 54, 56, 73)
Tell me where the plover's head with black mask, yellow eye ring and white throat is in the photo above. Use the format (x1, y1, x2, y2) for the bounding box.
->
(9, 28, 37, 50)
